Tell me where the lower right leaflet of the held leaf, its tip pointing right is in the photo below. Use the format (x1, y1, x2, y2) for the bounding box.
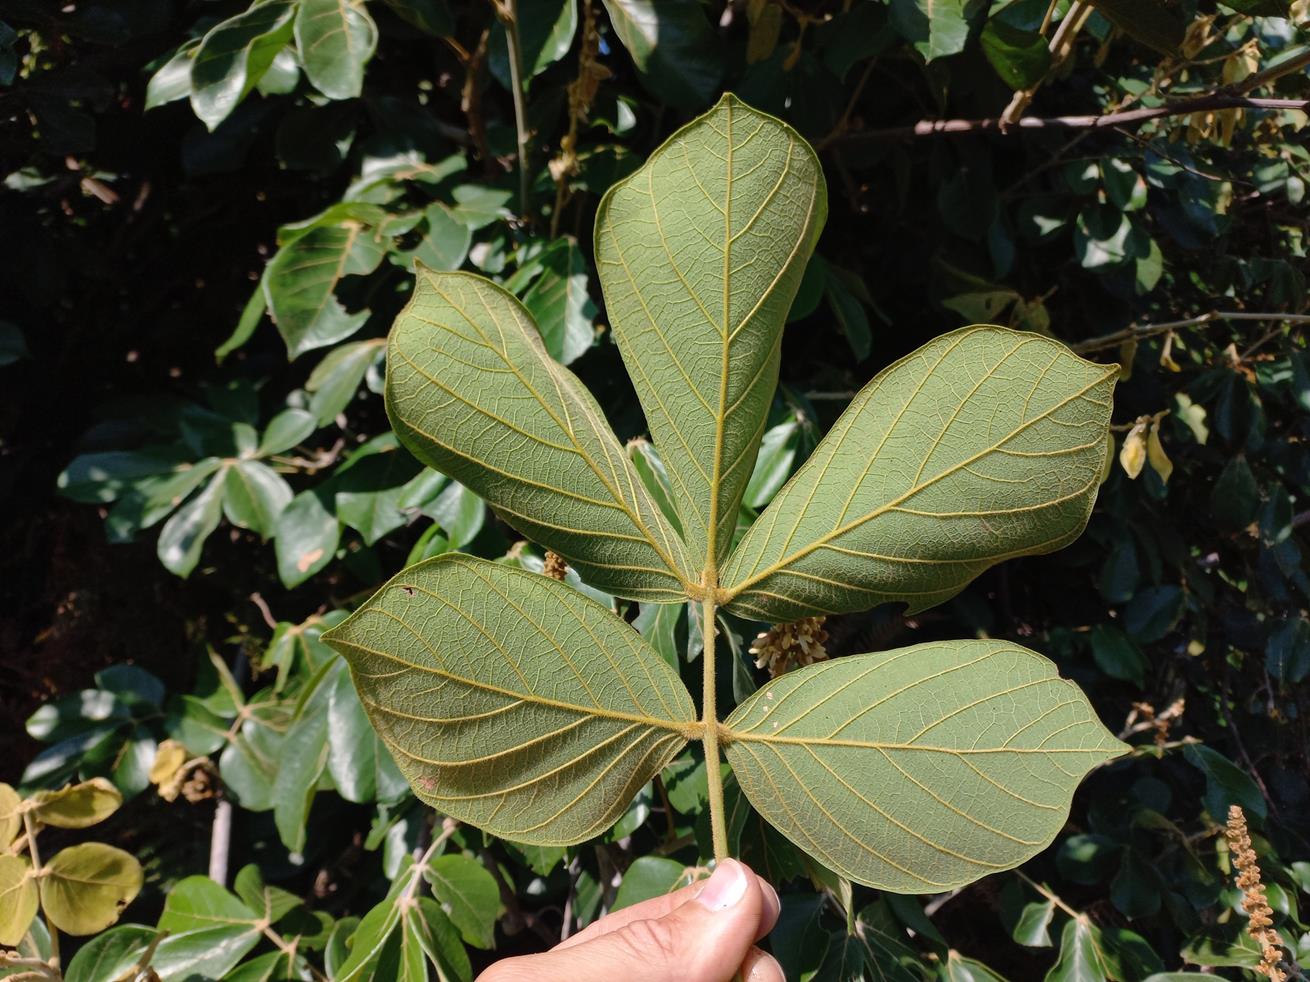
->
(721, 640, 1128, 893)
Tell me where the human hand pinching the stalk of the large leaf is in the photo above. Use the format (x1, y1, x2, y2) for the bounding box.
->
(477, 859, 785, 982)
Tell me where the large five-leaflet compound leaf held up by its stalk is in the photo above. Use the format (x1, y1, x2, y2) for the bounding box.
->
(324, 96, 1123, 892)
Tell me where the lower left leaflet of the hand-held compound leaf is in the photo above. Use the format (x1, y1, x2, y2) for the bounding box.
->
(322, 554, 700, 846)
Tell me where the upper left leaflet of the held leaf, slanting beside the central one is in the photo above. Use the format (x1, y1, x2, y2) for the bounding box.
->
(386, 270, 692, 602)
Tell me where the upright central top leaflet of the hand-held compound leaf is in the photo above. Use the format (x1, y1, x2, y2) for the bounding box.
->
(596, 96, 828, 570)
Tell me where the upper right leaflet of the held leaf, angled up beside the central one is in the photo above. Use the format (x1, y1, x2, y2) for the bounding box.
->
(721, 327, 1117, 621)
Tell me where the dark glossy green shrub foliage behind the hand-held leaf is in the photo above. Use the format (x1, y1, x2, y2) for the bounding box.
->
(0, 0, 1310, 982)
